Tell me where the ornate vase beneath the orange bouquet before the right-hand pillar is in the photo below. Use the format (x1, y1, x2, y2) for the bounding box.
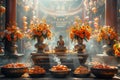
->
(105, 40, 114, 56)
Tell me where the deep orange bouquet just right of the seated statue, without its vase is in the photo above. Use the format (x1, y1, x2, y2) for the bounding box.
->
(70, 22, 91, 40)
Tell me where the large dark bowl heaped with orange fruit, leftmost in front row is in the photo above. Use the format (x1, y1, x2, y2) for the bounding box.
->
(1, 63, 28, 77)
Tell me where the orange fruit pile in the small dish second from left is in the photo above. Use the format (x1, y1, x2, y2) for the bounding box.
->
(29, 66, 46, 74)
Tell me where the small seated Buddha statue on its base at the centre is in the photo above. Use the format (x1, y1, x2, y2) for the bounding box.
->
(55, 35, 67, 52)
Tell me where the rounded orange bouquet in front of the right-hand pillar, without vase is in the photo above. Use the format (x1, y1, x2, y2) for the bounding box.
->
(97, 26, 118, 42)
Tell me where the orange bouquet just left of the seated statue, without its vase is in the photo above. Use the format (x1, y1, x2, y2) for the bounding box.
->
(30, 23, 52, 39)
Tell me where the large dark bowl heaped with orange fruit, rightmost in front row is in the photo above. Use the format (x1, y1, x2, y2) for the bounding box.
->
(91, 64, 118, 78)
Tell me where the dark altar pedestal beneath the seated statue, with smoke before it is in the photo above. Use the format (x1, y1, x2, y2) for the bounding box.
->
(31, 53, 88, 71)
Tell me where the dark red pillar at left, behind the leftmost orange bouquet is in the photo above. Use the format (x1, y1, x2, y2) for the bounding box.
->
(4, 0, 16, 55)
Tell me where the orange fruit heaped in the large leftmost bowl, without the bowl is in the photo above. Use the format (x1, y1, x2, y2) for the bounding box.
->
(3, 63, 27, 68)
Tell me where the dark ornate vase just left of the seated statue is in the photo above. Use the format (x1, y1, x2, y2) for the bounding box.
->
(35, 37, 45, 53)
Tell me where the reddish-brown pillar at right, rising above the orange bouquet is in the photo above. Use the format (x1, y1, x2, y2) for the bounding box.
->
(105, 0, 117, 30)
